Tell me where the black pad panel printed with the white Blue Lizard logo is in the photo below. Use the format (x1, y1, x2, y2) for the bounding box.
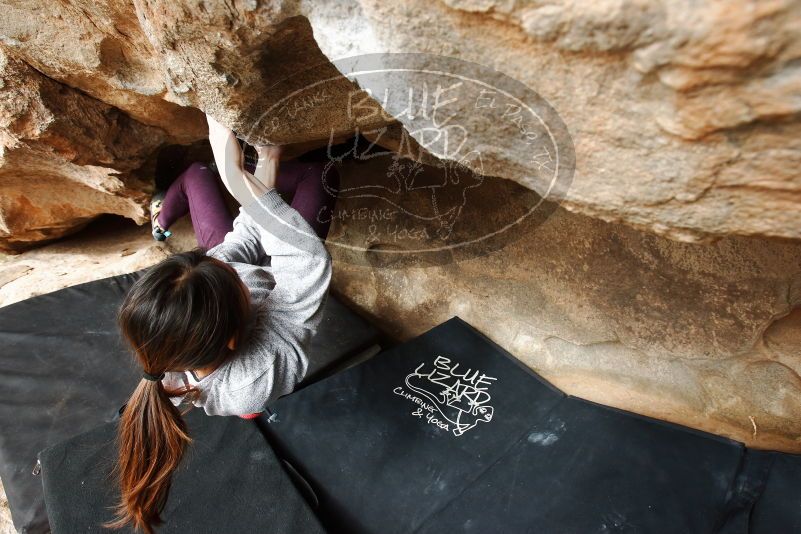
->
(263, 319, 565, 533)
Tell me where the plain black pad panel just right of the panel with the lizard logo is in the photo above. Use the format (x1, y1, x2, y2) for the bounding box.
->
(417, 398, 742, 534)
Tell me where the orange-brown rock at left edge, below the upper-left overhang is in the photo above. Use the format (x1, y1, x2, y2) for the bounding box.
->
(0, 51, 164, 249)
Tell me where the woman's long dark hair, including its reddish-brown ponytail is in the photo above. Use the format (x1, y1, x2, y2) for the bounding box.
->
(107, 250, 250, 534)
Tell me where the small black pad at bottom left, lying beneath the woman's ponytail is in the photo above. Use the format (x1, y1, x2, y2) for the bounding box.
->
(41, 410, 324, 534)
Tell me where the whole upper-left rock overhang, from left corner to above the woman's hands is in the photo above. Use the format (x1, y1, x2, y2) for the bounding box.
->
(0, 0, 394, 143)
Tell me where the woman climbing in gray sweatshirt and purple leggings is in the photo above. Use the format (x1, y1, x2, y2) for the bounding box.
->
(109, 113, 337, 534)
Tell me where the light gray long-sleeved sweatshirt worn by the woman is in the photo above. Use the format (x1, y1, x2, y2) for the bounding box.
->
(164, 189, 331, 415)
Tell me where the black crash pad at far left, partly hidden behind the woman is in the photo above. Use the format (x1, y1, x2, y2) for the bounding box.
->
(0, 271, 379, 533)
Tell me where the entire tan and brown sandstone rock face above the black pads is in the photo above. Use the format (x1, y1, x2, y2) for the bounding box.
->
(0, 0, 801, 456)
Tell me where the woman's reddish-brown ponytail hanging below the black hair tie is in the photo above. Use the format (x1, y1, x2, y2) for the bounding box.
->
(106, 379, 191, 534)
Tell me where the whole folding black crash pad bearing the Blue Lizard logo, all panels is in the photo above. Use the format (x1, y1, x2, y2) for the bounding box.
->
(260, 317, 801, 534)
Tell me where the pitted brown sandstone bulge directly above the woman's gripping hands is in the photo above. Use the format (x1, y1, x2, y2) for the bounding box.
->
(129, 0, 394, 144)
